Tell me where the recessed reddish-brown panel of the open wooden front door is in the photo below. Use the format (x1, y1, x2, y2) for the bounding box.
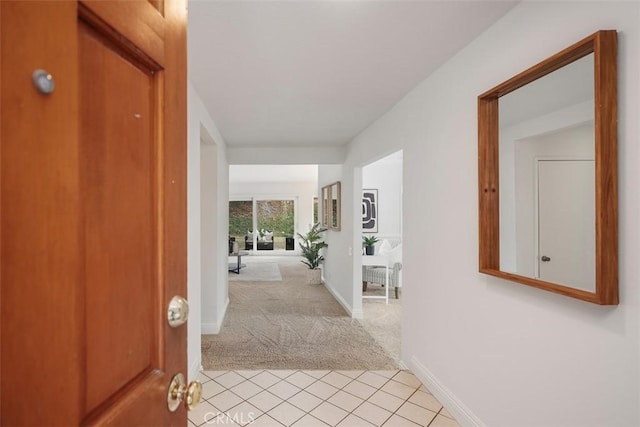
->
(79, 26, 162, 411)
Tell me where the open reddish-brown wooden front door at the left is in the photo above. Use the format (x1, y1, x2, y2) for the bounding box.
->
(0, 0, 187, 426)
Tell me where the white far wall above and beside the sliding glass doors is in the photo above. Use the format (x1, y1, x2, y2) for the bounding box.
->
(229, 180, 318, 247)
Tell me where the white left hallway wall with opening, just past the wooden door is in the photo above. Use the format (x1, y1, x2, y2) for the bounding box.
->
(187, 83, 229, 379)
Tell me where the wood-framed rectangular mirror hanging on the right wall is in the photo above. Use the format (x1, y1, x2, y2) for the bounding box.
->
(478, 30, 618, 305)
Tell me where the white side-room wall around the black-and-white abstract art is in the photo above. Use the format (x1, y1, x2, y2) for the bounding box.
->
(362, 153, 402, 239)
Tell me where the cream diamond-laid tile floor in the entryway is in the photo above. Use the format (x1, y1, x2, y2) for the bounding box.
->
(189, 370, 458, 427)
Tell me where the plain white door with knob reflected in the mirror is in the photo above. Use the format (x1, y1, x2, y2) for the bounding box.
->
(538, 160, 595, 291)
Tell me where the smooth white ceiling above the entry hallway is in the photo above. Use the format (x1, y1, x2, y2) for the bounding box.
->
(188, 0, 515, 147)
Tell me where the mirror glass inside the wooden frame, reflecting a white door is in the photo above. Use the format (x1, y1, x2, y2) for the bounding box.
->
(499, 53, 596, 292)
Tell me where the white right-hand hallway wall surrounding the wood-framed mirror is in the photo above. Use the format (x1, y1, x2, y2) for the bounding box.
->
(321, 1, 640, 426)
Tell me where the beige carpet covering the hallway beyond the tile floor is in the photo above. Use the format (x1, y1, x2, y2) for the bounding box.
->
(202, 256, 400, 370)
